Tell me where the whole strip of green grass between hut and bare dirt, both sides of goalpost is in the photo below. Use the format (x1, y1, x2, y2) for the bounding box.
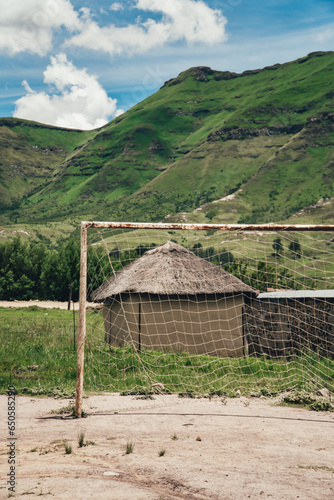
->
(0, 307, 334, 397)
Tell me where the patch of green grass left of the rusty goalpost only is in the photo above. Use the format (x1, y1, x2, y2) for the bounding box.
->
(0, 307, 80, 396)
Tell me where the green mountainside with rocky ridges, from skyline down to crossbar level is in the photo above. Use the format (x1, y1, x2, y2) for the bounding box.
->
(0, 52, 334, 238)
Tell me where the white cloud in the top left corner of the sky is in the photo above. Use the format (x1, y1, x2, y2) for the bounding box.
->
(0, 0, 80, 56)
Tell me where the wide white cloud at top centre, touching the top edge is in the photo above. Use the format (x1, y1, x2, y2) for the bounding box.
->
(67, 0, 227, 56)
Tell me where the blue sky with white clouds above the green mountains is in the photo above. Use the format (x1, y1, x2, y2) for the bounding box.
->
(0, 0, 334, 129)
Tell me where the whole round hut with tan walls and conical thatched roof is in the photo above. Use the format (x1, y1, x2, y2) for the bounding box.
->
(92, 241, 255, 357)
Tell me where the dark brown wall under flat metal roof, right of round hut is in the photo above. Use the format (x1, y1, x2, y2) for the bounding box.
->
(244, 298, 334, 358)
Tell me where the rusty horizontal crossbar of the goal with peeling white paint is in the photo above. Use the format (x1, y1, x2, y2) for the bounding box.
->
(81, 222, 334, 232)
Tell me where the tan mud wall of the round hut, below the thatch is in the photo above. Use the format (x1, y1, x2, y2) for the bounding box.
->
(104, 294, 245, 357)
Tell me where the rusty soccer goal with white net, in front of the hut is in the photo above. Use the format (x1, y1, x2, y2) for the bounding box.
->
(76, 222, 334, 417)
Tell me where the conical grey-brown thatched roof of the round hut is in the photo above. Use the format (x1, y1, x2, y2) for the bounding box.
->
(92, 241, 254, 300)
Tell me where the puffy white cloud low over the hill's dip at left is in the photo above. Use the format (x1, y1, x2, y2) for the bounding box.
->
(14, 54, 122, 130)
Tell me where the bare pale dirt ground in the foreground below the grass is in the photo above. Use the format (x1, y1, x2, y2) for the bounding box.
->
(0, 394, 334, 500)
